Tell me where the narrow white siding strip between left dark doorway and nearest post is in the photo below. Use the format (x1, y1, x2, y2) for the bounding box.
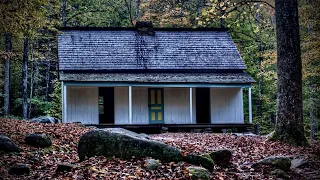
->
(114, 87, 129, 124)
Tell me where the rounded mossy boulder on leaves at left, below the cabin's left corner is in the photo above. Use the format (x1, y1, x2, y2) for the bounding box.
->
(24, 133, 52, 147)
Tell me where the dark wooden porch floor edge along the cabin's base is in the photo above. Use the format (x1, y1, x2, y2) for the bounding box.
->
(86, 124, 253, 134)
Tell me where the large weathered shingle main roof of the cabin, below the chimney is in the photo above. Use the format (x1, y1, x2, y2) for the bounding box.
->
(58, 29, 246, 71)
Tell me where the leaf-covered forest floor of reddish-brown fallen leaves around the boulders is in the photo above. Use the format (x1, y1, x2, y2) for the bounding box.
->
(0, 119, 320, 180)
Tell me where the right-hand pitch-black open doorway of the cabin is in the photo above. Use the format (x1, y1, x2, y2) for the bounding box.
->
(196, 88, 210, 124)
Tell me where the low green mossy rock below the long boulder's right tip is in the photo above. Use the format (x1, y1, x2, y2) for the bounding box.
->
(184, 154, 214, 171)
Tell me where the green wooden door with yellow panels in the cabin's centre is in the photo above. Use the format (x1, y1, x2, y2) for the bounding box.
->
(148, 88, 164, 124)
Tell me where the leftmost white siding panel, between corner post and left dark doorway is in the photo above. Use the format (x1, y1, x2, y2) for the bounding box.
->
(66, 87, 99, 124)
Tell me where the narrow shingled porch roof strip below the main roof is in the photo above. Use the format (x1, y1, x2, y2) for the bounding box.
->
(60, 72, 255, 84)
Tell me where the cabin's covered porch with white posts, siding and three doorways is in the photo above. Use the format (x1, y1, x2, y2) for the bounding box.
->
(62, 81, 252, 128)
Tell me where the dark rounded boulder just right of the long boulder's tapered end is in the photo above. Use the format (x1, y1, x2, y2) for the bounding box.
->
(209, 149, 232, 166)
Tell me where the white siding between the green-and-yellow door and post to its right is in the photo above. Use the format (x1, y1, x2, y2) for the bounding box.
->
(164, 88, 194, 124)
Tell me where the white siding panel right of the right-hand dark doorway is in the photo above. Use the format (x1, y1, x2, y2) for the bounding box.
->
(210, 88, 244, 124)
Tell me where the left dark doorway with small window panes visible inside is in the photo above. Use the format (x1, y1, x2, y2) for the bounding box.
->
(99, 87, 114, 124)
